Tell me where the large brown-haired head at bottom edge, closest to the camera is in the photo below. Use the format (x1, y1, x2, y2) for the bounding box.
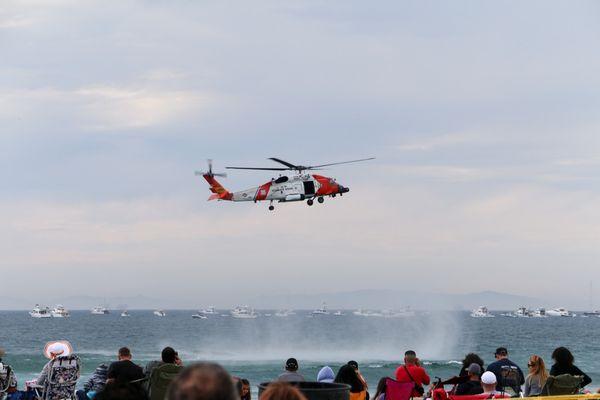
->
(167, 363, 238, 400)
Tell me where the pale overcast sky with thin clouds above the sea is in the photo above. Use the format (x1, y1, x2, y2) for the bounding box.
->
(0, 0, 600, 307)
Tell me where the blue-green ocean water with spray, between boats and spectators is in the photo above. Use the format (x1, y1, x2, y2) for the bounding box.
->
(0, 310, 600, 393)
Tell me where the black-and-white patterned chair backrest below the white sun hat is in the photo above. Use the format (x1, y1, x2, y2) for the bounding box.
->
(42, 355, 81, 400)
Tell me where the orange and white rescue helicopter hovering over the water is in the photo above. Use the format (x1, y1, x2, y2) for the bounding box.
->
(196, 157, 375, 211)
